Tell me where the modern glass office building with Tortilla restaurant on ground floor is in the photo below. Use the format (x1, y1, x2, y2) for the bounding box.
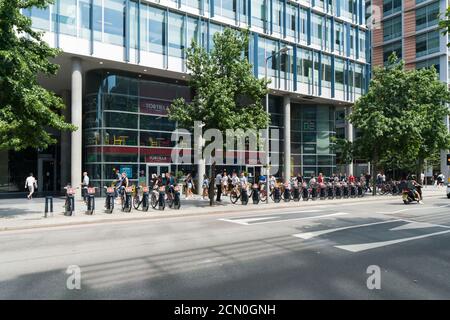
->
(0, 0, 371, 196)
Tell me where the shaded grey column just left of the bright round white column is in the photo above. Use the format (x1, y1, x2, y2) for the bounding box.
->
(60, 90, 71, 191)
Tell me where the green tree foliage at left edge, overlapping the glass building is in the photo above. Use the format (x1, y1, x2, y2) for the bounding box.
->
(0, 0, 76, 150)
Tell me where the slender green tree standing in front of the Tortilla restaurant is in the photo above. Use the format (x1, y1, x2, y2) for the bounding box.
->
(169, 28, 270, 204)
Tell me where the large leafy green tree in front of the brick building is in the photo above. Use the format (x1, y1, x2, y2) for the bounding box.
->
(349, 54, 450, 192)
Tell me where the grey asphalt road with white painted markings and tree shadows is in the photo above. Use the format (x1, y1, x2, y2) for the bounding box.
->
(0, 197, 450, 299)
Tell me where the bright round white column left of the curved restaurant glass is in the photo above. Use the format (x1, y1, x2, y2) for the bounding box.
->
(70, 58, 83, 196)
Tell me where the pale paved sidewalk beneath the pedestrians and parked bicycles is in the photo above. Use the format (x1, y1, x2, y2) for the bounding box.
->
(0, 187, 445, 231)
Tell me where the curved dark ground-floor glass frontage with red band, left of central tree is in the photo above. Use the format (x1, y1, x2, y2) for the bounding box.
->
(83, 70, 192, 187)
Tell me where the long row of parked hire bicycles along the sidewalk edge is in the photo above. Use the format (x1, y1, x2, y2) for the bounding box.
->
(59, 181, 402, 215)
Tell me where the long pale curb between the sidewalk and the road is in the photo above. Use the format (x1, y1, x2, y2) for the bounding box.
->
(0, 195, 444, 233)
